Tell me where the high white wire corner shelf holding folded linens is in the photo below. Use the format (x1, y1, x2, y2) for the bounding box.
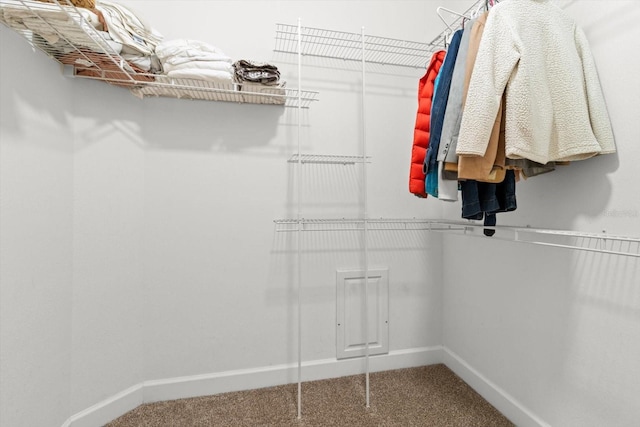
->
(0, 0, 318, 108)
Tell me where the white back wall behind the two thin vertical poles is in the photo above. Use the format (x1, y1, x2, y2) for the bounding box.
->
(132, 1, 456, 380)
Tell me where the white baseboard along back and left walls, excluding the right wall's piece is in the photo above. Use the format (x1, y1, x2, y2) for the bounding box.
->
(62, 346, 444, 427)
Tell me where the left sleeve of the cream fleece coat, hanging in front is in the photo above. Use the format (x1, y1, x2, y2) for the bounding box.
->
(456, 13, 521, 156)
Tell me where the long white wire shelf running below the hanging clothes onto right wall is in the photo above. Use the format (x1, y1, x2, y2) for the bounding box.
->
(274, 218, 640, 258)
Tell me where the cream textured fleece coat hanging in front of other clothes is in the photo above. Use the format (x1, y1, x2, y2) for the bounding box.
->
(456, 0, 616, 163)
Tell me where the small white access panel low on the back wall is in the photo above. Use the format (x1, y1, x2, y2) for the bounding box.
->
(336, 268, 389, 359)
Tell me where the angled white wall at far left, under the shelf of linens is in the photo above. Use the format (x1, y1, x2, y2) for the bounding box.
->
(0, 27, 144, 426)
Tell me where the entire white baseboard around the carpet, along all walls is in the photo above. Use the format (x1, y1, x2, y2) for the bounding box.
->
(62, 346, 549, 427)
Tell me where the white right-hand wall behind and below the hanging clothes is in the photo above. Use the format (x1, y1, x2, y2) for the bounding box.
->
(443, 1, 640, 426)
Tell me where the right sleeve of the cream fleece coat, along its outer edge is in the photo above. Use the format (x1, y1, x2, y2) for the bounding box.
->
(575, 27, 616, 154)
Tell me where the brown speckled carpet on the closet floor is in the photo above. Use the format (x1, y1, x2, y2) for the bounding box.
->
(107, 364, 513, 427)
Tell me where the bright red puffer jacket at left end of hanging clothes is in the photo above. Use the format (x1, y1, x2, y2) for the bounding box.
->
(409, 50, 446, 197)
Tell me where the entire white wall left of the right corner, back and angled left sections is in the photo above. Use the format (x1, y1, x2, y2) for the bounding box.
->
(0, 1, 468, 426)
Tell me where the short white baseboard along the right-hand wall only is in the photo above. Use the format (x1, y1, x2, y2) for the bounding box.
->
(443, 347, 549, 427)
